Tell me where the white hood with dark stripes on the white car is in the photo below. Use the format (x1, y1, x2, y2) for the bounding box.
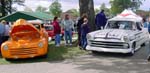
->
(91, 29, 133, 39)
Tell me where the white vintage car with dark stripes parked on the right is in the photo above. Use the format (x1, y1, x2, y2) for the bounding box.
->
(86, 9, 149, 55)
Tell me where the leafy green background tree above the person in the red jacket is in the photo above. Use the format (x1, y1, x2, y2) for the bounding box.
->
(49, 0, 62, 17)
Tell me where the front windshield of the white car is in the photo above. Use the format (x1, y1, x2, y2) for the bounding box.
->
(106, 21, 133, 30)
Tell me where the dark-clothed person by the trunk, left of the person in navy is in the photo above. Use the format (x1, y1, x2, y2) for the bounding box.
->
(77, 14, 87, 47)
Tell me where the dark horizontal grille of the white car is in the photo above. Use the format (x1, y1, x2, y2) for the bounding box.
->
(90, 41, 129, 49)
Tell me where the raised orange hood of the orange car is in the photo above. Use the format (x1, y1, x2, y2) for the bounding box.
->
(10, 20, 40, 41)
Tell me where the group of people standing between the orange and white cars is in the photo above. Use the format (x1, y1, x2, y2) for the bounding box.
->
(52, 10, 107, 49)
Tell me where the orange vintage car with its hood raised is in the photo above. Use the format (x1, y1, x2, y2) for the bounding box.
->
(1, 19, 48, 59)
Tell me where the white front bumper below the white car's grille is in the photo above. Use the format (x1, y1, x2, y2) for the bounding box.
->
(86, 45, 132, 53)
